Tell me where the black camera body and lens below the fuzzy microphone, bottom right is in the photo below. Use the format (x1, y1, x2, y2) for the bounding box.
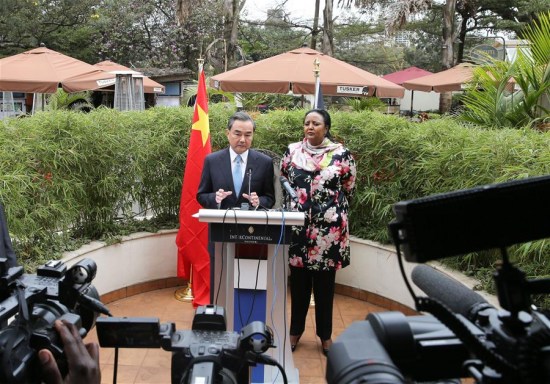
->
(326, 302, 550, 384)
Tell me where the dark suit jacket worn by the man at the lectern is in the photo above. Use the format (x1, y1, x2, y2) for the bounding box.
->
(197, 148, 275, 209)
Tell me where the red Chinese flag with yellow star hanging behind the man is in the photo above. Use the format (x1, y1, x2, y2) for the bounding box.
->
(176, 68, 211, 307)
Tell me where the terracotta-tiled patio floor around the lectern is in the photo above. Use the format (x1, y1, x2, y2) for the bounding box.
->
(85, 288, 385, 384)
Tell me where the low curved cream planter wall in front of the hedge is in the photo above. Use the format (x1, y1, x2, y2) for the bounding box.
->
(63, 230, 497, 308)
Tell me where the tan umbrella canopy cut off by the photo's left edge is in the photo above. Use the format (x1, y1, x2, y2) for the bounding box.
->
(0, 47, 114, 93)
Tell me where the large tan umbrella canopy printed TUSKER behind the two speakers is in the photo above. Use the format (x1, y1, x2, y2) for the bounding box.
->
(210, 48, 405, 98)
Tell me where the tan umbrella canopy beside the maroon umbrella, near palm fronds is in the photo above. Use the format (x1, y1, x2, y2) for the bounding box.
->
(403, 63, 475, 92)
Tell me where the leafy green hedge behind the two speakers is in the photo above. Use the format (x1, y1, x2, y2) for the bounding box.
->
(0, 104, 550, 274)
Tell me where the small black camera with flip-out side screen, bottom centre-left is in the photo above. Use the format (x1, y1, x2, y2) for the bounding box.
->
(96, 305, 286, 384)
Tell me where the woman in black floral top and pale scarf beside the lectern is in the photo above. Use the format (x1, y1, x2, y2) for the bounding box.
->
(281, 109, 356, 354)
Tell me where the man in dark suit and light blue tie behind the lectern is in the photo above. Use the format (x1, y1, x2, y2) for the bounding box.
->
(197, 112, 275, 209)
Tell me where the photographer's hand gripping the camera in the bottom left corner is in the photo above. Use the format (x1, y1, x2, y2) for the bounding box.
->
(38, 320, 101, 384)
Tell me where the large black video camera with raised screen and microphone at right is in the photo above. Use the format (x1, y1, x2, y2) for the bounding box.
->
(326, 176, 550, 384)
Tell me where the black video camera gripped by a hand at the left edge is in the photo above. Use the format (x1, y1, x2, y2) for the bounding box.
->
(0, 258, 108, 383)
